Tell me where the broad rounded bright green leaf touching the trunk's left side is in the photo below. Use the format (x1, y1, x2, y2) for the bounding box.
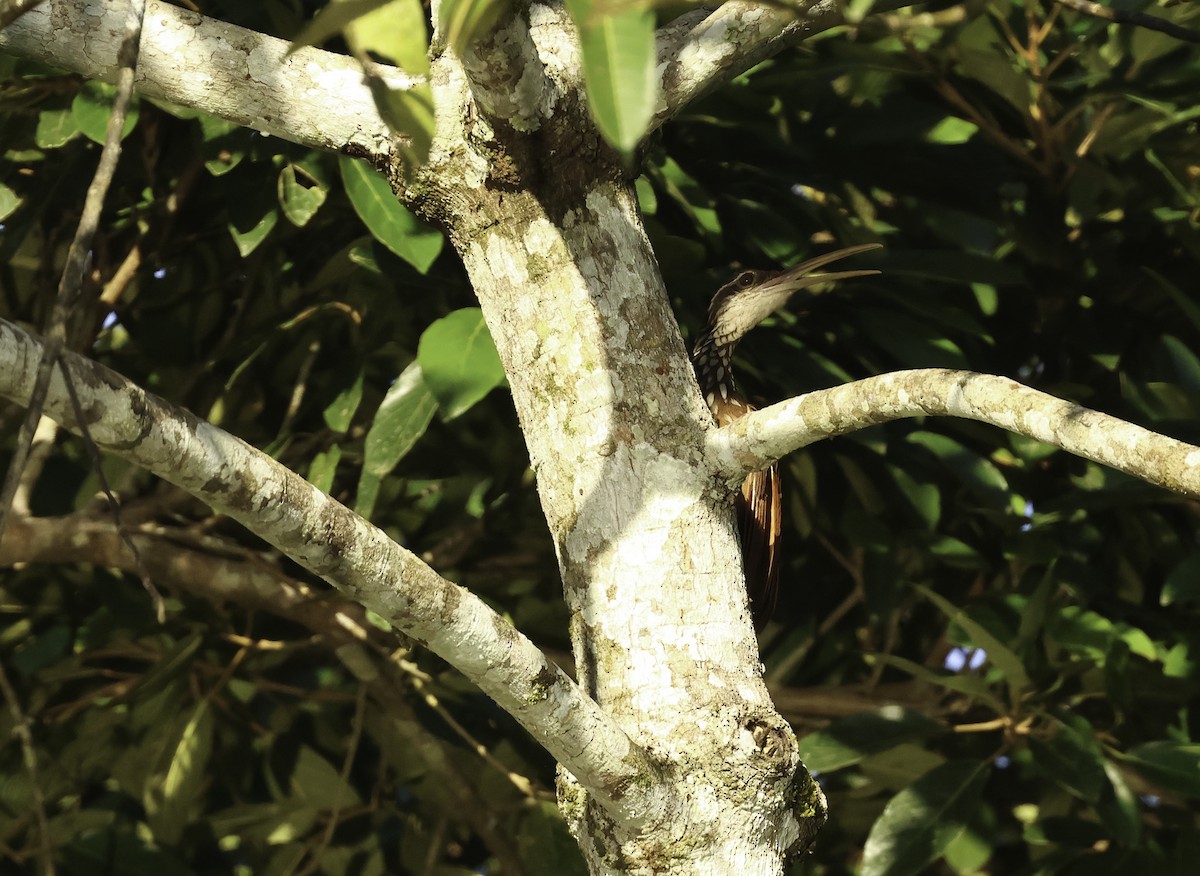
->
(416, 307, 504, 420)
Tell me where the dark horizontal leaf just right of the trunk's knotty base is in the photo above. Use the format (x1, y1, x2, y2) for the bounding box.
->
(798, 706, 942, 773)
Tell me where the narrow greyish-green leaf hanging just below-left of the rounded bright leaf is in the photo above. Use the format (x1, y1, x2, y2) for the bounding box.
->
(354, 362, 438, 518)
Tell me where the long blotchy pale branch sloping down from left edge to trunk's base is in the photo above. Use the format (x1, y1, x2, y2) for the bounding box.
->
(0, 319, 670, 829)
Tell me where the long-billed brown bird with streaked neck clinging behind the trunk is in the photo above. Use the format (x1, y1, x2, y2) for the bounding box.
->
(691, 244, 880, 630)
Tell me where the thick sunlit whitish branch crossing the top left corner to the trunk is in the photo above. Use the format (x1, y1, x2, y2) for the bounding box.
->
(0, 0, 405, 155)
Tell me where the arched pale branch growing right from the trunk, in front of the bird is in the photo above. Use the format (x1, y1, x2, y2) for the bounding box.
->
(708, 368, 1200, 498)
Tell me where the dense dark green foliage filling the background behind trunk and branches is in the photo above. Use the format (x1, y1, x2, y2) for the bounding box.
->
(0, 0, 1200, 876)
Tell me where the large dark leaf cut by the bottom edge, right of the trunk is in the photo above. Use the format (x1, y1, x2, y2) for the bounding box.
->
(859, 761, 989, 876)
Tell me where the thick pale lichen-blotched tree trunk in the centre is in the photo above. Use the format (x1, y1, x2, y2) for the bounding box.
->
(409, 18, 824, 874)
